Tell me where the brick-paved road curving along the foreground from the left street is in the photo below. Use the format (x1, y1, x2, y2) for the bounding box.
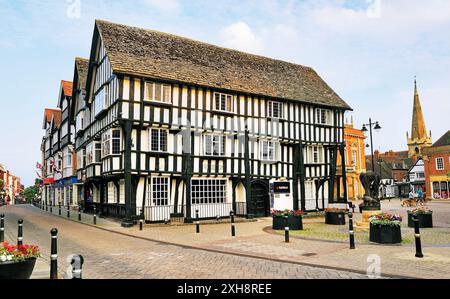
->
(0, 206, 367, 279)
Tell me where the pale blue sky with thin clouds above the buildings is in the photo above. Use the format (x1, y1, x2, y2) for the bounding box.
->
(0, 0, 450, 185)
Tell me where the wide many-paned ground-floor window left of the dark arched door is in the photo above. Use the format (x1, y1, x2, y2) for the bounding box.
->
(191, 179, 227, 204)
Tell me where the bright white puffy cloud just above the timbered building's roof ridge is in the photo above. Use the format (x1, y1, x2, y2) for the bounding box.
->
(220, 21, 264, 54)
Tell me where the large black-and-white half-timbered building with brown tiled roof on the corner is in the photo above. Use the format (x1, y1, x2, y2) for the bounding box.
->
(76, 21, 351, 226)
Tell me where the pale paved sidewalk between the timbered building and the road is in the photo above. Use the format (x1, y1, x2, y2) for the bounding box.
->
(34, 203, 450, 278)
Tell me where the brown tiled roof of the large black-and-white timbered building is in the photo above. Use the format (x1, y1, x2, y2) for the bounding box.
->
(88, 20, 351, 109)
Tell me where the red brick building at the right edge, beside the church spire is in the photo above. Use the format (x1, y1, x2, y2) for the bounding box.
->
(423, 130, 450, 199)
